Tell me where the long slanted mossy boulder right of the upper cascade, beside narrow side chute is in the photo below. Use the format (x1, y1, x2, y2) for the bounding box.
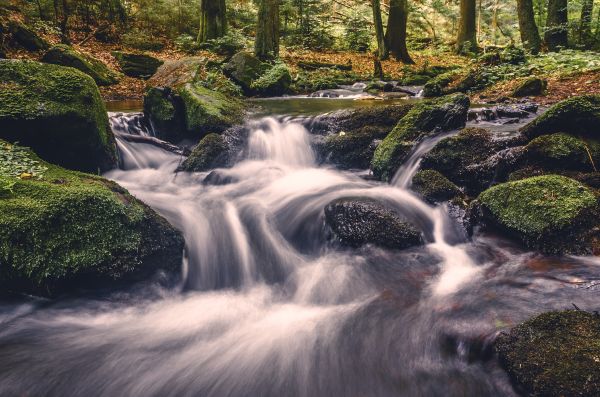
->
(371, 94, 470, 180)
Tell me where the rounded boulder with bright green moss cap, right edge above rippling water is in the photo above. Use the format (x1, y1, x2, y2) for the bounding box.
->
(478, 175, 598, 254)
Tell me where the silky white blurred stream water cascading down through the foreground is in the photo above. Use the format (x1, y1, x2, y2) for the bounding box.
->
(0, 100, 600, 397)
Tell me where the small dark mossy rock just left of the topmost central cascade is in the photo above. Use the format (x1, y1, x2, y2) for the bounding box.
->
(177, 134, 228, 172)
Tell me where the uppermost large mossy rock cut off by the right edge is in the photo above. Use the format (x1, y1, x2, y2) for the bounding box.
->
(521, 95, 600, 139)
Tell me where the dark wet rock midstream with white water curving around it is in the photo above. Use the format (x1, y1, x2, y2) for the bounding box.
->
(325, 198, 422, 249)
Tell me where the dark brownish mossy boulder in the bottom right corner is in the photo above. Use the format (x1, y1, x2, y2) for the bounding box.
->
(495, 310, 600, 397)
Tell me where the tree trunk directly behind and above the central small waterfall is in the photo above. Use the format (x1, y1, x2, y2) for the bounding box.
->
(254, 0, 279, 59)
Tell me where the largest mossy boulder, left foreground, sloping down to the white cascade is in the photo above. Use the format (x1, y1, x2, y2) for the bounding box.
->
(0, 141, 183, 295)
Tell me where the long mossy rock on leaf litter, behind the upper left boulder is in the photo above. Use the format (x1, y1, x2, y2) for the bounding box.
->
(42, 44, 119, 85)
